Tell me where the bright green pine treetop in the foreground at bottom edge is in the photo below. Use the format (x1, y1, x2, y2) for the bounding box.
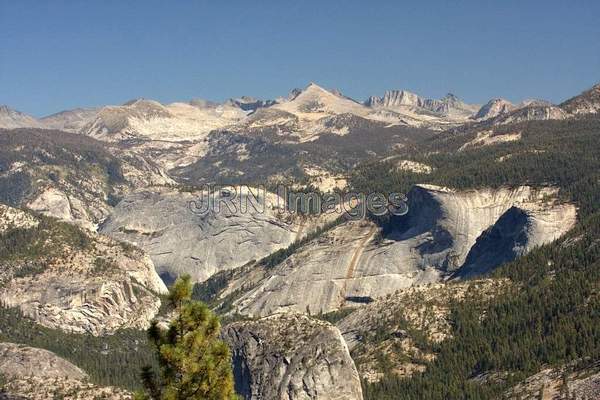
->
(136, 276, 237, 400)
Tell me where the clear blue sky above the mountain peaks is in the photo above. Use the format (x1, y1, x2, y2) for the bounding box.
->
(0, 0, 600, 116)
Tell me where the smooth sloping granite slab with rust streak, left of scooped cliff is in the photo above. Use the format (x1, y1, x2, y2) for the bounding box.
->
(226, 221, 382, 316)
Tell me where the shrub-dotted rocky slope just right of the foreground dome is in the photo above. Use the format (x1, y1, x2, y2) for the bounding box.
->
(336, 279, 510, 382)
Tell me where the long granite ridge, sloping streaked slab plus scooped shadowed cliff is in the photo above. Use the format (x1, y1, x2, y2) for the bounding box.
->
(211, 185, 576, 316)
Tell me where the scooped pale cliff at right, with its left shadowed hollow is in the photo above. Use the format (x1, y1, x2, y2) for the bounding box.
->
(364, 185, 576, 273)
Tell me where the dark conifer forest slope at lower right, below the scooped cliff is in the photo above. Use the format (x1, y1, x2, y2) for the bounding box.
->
(365, 203, 600, 400)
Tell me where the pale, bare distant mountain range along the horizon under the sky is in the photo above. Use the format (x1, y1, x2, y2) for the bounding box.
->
(0, 83, 599, 136)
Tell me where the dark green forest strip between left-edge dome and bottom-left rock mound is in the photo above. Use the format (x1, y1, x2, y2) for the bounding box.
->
(0, 307, 156, 390)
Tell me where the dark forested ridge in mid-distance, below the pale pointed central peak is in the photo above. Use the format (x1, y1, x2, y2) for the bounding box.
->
(172, 119, 435, 185)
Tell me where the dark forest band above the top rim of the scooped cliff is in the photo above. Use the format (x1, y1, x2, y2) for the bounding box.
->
(350, 118, 600, 215)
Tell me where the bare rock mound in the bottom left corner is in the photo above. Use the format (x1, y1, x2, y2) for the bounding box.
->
(0, 343, 131, 400)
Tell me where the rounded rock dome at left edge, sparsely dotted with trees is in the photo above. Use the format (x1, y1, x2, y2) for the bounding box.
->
(0, 205, 166, 335)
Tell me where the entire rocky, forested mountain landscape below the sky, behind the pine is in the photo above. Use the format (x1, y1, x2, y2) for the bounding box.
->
(0, 83, 600, 400)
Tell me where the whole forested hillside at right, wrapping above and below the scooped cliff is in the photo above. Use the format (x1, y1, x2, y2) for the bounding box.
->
(352, 115, 600, 400)
